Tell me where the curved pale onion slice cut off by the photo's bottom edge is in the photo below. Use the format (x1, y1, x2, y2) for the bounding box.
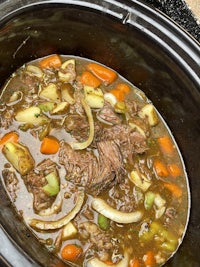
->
(85, 252, 129, 267)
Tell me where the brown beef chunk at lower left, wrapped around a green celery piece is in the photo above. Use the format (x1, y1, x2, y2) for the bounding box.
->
(24, 159, 56, 212)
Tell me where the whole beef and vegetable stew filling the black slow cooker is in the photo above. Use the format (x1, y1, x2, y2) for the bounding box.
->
(0, 55, 189, 267)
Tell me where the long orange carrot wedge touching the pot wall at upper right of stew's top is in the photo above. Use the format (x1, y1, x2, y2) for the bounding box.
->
(87, 63, 117, 84)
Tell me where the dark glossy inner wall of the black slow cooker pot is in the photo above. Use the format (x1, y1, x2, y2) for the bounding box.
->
(0, 4, 200, 267)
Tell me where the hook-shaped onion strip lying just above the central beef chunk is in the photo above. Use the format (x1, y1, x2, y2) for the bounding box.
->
(70, 99, 94, 150)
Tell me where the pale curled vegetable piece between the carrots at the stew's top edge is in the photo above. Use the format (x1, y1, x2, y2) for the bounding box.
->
(58, 59, 75, 82)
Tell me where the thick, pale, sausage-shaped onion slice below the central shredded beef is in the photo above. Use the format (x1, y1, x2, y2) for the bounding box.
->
(92, 198, 143, 223)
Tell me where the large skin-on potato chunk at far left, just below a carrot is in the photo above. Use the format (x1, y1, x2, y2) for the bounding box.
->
(2, 142, 35, 175)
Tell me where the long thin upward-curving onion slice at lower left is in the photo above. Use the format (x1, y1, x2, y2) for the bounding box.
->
(29, 191, 85, 230)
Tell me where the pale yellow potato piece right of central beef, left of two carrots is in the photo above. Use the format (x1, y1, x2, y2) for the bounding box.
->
(130, 170, 151, 192)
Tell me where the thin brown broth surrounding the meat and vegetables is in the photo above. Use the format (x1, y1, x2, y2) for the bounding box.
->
(0, 56, 190, 266)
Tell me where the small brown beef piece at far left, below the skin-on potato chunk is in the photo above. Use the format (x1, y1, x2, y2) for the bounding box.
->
(2, 169, 19, 201)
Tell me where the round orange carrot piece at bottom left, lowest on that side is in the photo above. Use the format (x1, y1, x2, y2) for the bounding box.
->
(61, 244, 83, 261)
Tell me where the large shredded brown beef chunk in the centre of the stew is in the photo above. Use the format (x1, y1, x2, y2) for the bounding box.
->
(59, 141, 122, 195)
